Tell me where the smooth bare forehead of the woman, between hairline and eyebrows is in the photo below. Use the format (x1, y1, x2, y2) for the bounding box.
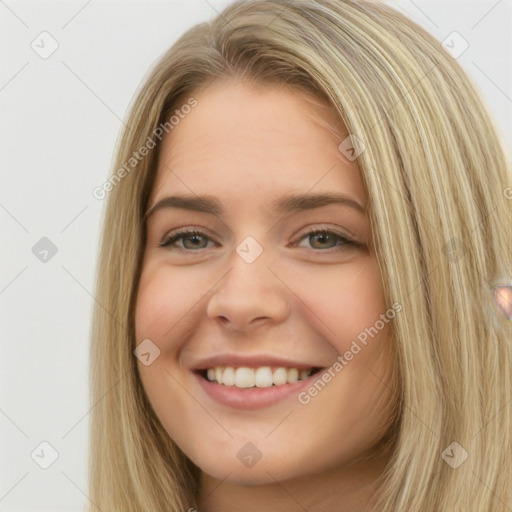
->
(152, 81, 365, 206)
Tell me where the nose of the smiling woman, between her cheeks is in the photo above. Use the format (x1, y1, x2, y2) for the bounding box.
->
(207, 247, 291, 331)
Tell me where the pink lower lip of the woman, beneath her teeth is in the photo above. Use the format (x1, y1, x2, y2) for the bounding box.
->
(194, 370, 322, 410)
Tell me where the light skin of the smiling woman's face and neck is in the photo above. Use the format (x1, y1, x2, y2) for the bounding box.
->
(135, 81, 400, 512)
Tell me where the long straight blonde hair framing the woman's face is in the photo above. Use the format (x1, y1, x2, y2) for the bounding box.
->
(88, 0, 512, 512)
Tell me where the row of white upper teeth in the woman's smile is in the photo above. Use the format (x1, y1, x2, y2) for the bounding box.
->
(207, 366, 313, 388)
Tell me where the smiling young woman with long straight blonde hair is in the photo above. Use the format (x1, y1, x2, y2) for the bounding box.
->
(89, 0, 512, 512)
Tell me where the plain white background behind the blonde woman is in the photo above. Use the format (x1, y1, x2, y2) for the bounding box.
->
(0, 0, 512, 512)
